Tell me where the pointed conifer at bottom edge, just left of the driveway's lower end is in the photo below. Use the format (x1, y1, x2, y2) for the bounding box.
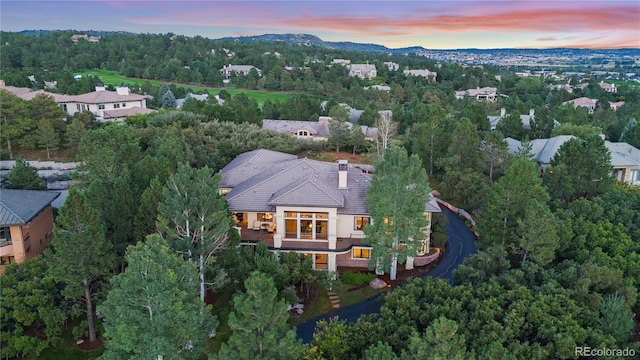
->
(213, 272, 302, 360)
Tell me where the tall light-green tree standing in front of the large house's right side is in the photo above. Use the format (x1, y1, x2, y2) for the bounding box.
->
(363, 147, 430, 280)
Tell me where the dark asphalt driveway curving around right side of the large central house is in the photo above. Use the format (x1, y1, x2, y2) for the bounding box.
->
(297, 208, 476, 343)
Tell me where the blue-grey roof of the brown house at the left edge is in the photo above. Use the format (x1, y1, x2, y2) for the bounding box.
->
(0, 189, 60, 226)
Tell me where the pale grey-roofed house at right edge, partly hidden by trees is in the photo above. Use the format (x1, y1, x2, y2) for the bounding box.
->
(505, 135, 640, 185)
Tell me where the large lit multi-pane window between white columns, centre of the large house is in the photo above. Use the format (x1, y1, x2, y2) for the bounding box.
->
(284, 212, 329, 240)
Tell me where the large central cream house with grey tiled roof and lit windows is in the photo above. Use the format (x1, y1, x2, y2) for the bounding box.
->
(220, 149, 441, 271)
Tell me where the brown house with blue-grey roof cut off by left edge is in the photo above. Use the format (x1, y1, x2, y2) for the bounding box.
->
(0, 189, 60, 273)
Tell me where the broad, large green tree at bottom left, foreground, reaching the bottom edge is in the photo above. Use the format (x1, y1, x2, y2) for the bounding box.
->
(99, 234, 216, 360)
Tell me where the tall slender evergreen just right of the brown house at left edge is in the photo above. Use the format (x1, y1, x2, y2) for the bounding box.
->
(50, 187, 115, 341)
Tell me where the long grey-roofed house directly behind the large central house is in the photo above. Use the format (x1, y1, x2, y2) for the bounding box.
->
(262, 116, 378, 141)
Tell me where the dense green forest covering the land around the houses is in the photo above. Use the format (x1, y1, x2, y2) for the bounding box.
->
(0, 31, 640, 359)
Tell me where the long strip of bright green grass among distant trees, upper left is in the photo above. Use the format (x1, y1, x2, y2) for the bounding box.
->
(74, 70, 293, 107)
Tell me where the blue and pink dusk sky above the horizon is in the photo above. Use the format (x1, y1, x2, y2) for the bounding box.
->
(0, 0, 640, 49)
